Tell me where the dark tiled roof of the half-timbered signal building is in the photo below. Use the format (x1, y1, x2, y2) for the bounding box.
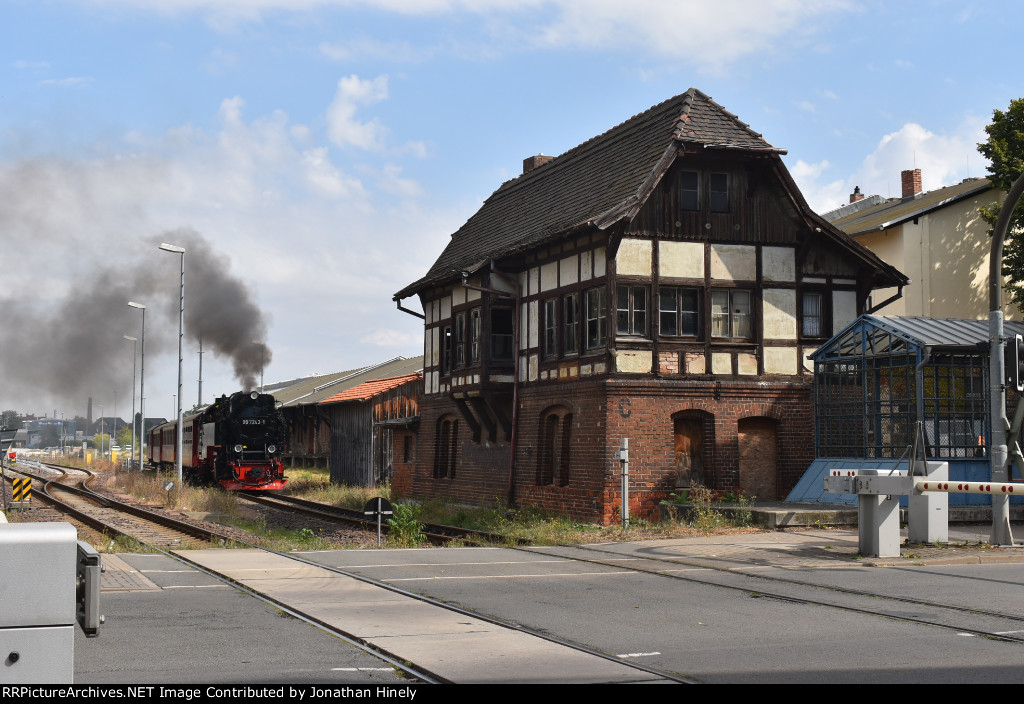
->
(394, 88, 782, 300)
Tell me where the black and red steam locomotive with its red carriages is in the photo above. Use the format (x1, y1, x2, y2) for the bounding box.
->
(146, 391, 288, 491)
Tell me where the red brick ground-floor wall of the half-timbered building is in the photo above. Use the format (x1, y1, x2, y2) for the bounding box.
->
(403, 379, 814, 524)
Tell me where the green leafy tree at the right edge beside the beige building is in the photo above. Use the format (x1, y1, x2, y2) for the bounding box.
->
(978, 98, 1024, 311)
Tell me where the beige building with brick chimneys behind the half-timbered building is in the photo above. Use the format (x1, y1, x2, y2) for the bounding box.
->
(822, 169, 1022, 320)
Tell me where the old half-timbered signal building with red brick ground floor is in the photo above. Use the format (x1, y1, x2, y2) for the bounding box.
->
(394, 89, 907, 522)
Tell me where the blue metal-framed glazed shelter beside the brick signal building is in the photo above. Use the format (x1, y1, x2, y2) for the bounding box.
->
(786, 315, 1024, 505)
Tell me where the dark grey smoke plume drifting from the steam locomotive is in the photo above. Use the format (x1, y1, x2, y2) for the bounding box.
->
(0, 228, 271, 416)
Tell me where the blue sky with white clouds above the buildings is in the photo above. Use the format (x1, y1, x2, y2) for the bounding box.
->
(0, 0, 1024, 416)
